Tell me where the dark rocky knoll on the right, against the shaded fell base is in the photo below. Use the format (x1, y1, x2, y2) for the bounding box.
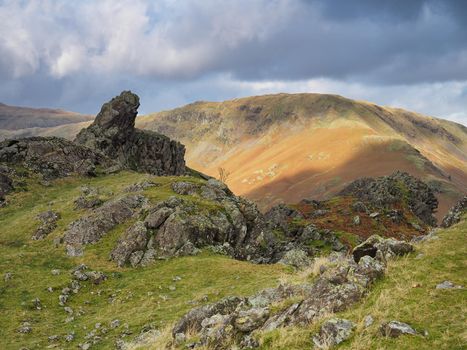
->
(340, 171, 438, 226)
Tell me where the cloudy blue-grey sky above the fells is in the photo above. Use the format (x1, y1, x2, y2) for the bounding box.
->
(0, 0, 467, 125)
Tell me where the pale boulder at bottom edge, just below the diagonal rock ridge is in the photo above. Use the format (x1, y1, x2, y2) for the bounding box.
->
(313, 318, 355, 349)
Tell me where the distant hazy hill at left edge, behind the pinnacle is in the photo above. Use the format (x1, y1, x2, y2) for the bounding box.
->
(0, 103, 94, 134)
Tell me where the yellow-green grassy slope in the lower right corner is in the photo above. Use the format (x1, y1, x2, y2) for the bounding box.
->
(261, 220, 467, 350)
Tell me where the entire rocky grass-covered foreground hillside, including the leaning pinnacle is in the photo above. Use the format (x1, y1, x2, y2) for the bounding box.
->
(0, 91, 467, 350)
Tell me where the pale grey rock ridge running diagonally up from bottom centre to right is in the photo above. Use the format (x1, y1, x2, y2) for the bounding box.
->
(172, 235, 414, 349)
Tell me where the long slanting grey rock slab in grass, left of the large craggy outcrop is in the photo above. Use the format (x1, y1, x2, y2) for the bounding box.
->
(63, 195, 144, 256)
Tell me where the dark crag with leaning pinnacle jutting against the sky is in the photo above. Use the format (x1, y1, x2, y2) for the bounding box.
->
(74, 91, 185, 175)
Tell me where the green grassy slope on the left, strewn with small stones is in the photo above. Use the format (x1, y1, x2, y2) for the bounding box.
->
(0, 172, 288, 349)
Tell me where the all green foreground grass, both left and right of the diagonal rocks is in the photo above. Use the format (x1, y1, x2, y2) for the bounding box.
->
(0, 172, 467, 350)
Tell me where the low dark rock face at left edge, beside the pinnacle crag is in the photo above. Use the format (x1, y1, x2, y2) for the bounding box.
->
(0, 137, 115, 179)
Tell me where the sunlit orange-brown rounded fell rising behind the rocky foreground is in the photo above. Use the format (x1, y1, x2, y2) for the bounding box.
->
(137, 94, 467, 218)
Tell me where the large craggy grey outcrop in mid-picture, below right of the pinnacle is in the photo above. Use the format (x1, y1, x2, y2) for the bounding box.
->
(111, 179, 277, 266)
